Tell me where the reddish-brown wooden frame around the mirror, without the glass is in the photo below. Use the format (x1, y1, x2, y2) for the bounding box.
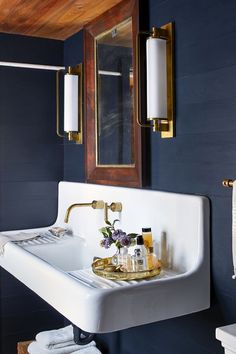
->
(84, 0, 142, 187)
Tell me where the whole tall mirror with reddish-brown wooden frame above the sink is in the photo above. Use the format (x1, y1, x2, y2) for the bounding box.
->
(84, 0, 142, 187)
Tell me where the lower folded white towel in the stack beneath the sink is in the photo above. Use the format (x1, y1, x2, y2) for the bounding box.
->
(28, 341, 96, 354)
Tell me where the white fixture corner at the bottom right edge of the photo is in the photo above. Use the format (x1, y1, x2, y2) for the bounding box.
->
(216, 323, 236, 354)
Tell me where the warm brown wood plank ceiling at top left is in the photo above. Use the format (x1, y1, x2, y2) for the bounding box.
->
(0, 0, 124, 40)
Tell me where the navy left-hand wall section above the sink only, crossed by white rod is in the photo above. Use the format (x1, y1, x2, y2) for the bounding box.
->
(0, 34, 63, 230)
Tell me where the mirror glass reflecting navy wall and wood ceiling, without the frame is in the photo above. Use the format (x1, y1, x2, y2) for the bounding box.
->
(95, 18, 134, 166)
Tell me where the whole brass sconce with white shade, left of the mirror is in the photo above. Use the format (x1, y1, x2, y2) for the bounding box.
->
(56, 64, 83, 144)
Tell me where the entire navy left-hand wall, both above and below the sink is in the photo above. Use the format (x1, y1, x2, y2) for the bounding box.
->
(0, 34, 64, 354)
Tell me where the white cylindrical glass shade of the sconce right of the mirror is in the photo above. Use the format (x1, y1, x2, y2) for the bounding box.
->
(146, 37, 167, 119)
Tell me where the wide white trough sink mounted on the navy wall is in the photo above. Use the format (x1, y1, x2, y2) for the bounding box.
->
(0, 182, 210, 333)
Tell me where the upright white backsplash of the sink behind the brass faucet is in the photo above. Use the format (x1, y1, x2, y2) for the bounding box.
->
(56, 182, 208, 272)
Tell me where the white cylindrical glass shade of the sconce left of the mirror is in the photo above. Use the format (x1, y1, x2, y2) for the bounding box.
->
(64, 74, 79, 132)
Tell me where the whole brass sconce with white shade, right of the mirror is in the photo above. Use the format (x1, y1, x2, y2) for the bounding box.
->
(136, 23, 174, 138)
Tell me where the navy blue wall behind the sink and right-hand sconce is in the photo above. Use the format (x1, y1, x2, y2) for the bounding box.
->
(65, 0, 236, 354)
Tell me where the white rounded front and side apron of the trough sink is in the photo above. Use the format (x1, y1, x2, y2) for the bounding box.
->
(2, 230, 209, 333)
